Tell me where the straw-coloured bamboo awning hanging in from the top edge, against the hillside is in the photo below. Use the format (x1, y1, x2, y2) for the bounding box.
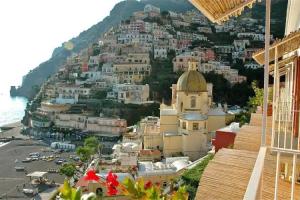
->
(189, 0, 256, 24)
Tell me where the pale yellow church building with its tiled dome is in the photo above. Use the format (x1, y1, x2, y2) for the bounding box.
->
(143, 62, 226, 161)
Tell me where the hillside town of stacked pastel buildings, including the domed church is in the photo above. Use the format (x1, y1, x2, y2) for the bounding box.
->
(5, 4, 288, 199)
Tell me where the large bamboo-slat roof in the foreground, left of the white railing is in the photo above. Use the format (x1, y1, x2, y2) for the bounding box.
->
(195, 149, 257, 200)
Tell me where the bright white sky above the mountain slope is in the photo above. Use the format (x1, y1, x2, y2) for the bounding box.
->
(0, 0, 121, 94)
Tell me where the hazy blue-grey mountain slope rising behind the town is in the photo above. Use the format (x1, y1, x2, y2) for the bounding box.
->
(11, 0, 193, 98)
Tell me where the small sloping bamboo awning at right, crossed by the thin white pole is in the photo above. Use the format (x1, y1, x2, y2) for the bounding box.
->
(252, 30, 300, 65)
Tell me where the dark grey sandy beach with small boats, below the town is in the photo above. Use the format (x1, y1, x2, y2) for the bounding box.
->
(0, 140, 72, 199)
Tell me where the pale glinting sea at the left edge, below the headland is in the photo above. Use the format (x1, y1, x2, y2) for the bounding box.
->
(0, 90, 27, 127)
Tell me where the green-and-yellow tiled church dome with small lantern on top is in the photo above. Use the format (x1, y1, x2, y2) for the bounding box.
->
(177, 62, 207, 93)
